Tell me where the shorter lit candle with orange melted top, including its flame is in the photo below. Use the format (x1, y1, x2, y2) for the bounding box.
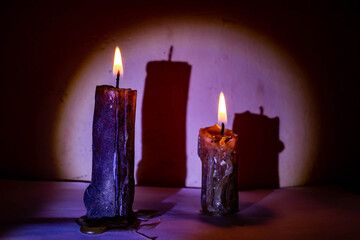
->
(198, 92, 238, 216)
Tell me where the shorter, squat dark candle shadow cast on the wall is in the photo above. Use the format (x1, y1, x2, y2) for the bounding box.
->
(233, 107, 284, 190)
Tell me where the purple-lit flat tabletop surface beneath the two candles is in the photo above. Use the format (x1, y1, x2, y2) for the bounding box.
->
(0, 180, 360, 240)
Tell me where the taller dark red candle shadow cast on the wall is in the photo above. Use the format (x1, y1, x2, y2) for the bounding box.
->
(136, 48, 191, 187)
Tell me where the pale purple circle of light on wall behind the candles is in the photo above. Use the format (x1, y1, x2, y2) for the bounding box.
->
(53, 18, 318, 187)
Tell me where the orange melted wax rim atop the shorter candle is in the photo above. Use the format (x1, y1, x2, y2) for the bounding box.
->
(199, 124, 238, 148)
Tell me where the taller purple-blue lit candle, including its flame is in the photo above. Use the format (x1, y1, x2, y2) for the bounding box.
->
(84, 47, 137, 219)
